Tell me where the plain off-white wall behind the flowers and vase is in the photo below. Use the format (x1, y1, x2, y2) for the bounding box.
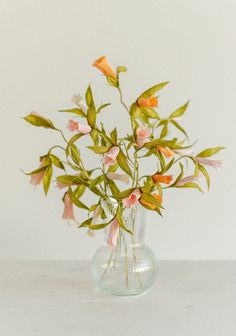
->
(0, 0, 236, 259)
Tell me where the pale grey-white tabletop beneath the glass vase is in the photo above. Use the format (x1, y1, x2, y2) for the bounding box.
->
(0, 261, 236, 336)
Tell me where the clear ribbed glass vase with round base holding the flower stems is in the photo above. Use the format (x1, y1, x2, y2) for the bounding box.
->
(91, 202, 157, 296)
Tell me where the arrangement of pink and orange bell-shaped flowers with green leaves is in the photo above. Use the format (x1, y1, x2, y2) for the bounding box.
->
(24, 56, 223, 245)
